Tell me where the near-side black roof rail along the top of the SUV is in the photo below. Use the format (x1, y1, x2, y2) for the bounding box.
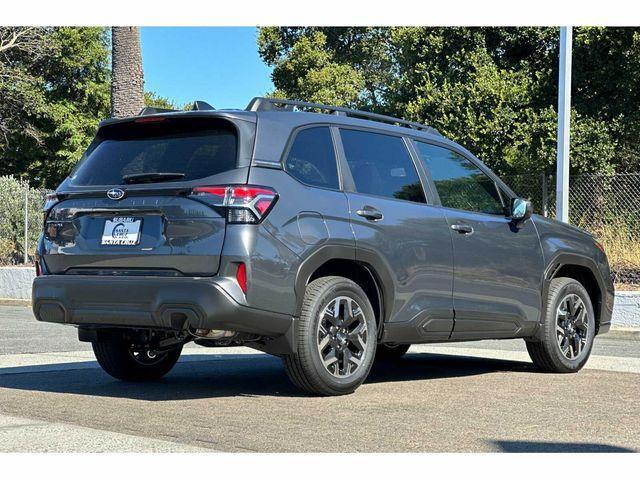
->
(246, 97, 440, 135)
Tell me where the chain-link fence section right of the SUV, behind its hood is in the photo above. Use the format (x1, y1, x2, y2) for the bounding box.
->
(502, 173, 640, 289)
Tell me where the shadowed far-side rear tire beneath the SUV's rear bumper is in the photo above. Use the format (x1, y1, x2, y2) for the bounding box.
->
(91, 336, 182, 382)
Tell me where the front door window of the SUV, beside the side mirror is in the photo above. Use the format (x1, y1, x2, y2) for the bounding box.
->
(416, 142, 505, 215)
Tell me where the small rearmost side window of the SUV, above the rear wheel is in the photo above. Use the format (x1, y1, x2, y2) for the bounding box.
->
(285, 127, 340, 189)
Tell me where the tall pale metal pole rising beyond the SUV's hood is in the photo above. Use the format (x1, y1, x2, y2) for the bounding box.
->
(556, 27, 572, 222)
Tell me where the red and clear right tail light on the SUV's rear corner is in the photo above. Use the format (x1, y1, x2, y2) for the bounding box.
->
(191, 185, 278, 223)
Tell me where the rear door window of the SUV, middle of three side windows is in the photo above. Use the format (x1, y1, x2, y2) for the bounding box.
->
(340, 129, 425, 203)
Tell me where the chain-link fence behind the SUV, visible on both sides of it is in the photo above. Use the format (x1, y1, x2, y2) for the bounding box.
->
(0, 173, 640, 289)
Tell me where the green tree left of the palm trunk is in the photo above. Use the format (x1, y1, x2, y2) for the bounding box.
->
(0, 27, 110, 187)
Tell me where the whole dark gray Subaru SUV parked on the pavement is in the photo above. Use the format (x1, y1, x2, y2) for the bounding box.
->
(33, 98, 614, 395)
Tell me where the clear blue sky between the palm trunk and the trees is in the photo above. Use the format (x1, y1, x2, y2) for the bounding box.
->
(140, 27, 273, 108)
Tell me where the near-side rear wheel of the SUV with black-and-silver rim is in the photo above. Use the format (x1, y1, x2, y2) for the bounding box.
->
(283, 277, 377, 395)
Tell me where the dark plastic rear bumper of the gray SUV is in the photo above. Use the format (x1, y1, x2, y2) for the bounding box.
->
(32, 275, 293, 337)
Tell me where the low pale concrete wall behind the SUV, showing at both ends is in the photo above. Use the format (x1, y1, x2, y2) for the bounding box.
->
(0, 266, 640, 328)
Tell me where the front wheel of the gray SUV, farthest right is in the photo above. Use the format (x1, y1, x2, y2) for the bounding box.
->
(526, 277, 595, 373)
